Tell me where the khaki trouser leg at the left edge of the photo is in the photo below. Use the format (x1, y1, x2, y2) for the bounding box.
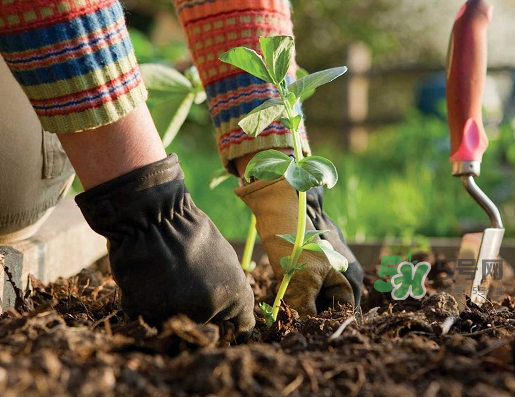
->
(0, 57, 73, 244)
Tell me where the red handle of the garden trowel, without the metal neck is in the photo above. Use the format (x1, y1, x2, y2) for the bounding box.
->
(446, 0, 492, 162)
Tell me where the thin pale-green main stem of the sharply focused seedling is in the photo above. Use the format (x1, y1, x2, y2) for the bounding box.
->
(272, 87, 307, 321)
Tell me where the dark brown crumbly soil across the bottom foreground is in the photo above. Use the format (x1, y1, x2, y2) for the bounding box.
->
(0, 255, 515, 397)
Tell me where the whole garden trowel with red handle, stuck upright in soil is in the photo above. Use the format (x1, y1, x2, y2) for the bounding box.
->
(446, 0, 504, 311)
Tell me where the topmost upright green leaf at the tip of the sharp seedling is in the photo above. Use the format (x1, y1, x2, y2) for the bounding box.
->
(259, 36, 294, 85)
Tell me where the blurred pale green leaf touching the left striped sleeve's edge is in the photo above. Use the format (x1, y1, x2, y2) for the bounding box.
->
(140, 63, 193, 97)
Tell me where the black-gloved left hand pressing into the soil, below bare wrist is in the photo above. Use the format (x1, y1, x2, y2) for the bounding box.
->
(76, 154, 255, 340)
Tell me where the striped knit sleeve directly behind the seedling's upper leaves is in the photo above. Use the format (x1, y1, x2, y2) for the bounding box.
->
(173, 0, 309, 173)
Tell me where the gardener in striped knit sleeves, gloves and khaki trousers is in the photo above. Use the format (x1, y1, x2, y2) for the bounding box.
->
(0, 0, 362, 339)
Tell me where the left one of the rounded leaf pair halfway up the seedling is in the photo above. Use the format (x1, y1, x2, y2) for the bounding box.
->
(245, 149, 293, 181)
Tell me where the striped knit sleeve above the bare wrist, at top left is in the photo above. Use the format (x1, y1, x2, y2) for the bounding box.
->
(0, 0, 147, 133)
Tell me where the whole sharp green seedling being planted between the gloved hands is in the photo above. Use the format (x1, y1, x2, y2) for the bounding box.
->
(220, 36, 348, 326)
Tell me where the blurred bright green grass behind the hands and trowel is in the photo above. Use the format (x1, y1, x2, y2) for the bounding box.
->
(169, 111, 514, 241)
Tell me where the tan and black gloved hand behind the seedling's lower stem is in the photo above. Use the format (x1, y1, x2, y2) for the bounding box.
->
(235, 178, 363, 316)
